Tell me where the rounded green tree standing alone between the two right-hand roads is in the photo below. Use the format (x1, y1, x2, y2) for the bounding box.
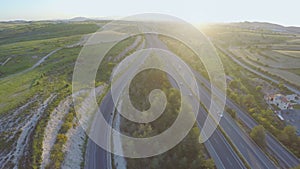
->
(250, 125, 266, 147)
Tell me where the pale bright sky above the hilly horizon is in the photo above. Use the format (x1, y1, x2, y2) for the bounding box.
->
(0, 0, 300, 26)
